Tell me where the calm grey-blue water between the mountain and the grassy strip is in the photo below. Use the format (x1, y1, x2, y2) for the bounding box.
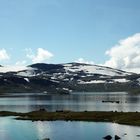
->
(0, 92, 140, 112)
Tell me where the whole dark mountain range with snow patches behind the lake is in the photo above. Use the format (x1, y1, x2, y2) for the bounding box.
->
(0, 63, 140, 92)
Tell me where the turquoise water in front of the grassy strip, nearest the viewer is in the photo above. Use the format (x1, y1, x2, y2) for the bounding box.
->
(0, 117, 140, 140)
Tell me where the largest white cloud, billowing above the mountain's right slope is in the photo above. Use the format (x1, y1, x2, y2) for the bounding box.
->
(104, 33, 140, 73)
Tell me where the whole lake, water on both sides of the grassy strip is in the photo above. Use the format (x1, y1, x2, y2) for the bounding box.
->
(0, 92, 140, 140)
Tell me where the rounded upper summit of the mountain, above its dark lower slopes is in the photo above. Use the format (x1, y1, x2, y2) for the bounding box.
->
(17, 63, 132, 77)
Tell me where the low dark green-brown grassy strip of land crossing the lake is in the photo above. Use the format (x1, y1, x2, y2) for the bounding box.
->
(0, 111, 140, 126)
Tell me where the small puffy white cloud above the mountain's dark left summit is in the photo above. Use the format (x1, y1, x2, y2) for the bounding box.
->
(26, 48, 53, 63)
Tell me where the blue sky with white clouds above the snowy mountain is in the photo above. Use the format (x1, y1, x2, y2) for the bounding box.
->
(0, 0, 140, 71)
